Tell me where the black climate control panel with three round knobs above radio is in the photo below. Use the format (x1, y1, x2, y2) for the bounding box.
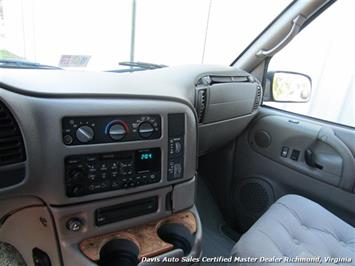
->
(62, 115, 161, 145)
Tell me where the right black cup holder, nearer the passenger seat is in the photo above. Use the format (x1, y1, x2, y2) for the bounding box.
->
(158, 223, 194, 255)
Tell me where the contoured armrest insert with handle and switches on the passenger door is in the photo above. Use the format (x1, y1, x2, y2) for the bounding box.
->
(249, 115, 355, 191)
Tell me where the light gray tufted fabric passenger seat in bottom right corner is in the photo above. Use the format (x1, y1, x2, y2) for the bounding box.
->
(232, 195, 355, 266)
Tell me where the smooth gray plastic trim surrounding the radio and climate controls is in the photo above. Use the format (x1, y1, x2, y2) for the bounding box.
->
(0, 89, 197, 205)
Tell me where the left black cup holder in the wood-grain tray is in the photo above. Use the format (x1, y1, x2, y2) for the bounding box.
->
(98, 239, 139, 266)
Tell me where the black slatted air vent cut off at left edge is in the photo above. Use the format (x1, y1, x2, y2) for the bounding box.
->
(0, 102, 26, 166)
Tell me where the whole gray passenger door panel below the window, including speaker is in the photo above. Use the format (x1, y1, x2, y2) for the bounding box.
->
(225, 106, 355, 232)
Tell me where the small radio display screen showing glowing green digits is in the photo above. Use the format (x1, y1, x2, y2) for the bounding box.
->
(135, 148, 161, 173)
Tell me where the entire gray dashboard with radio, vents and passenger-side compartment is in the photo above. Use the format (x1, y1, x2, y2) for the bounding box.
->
(0, 66, 262, 265)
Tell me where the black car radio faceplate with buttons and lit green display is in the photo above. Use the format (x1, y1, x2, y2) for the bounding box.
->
(65, 148, 161, 197)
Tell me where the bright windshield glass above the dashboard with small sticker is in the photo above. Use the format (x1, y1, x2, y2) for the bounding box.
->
(0, 0, 290, 70)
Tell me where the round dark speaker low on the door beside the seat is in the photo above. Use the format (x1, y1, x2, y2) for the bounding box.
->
(233, 177, 275, 232)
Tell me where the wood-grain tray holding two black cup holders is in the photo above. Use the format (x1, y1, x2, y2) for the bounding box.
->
(79, 211, 197, 266)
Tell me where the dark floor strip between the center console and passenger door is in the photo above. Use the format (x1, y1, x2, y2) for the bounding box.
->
(196, 177, 235, 265)
